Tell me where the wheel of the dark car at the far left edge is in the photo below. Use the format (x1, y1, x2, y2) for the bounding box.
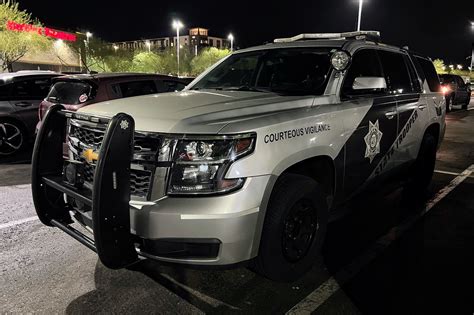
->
(0, 119, 27, 158)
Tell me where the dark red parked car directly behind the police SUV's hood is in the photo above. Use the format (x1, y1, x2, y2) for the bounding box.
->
(37, 73, 193, 130)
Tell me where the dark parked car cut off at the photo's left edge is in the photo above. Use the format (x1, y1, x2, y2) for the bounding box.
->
(0, 71, 61, 158)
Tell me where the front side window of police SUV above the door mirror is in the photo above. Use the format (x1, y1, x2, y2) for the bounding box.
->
(342, 49, 383, 96)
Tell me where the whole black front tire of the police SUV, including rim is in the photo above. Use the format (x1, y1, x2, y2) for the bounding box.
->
(251, 174, 328, 282)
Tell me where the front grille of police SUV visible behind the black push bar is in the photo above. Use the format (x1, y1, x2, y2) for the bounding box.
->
(69, 124, 160, 198)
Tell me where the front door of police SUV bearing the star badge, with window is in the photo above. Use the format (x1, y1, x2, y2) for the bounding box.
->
(341, 49, 398, 197)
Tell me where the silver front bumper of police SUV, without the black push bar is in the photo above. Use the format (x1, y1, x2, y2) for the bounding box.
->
(130, 176, 269, 265)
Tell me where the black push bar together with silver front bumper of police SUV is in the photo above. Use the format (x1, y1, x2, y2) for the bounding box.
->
(32, 106, 270, 269)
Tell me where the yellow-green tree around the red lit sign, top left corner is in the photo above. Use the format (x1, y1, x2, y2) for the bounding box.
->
(0, 0, 51, 72)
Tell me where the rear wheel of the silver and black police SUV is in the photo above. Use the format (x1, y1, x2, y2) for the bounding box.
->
(405, 133, 438, 198)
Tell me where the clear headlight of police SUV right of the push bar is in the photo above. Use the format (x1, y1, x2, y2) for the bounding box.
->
(168, 134, 255, 195)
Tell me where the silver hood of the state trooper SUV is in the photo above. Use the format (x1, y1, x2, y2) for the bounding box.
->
(79, 91, 314, 133)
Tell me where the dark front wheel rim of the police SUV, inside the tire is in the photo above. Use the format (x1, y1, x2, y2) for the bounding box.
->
(282, 199, 319, 263)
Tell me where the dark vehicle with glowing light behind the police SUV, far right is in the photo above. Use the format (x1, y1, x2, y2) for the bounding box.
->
(439, 74, 471, 112)
